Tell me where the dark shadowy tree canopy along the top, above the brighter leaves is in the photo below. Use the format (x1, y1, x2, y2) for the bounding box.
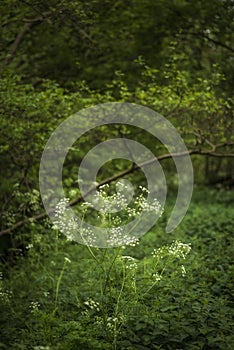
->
(0, 0, 233, 92)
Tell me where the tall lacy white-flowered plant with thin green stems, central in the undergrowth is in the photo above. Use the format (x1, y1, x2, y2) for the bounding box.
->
(51, 185, 191, 349)
